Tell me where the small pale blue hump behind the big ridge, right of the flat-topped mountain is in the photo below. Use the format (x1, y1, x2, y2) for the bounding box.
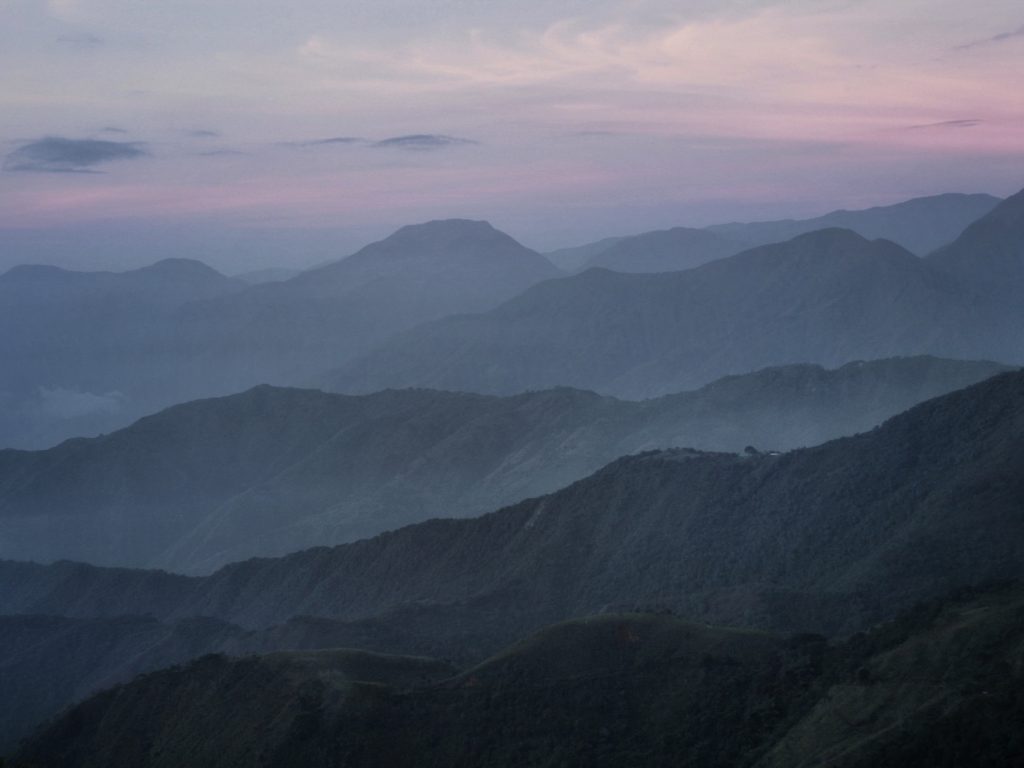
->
(585, 226, 749, 272)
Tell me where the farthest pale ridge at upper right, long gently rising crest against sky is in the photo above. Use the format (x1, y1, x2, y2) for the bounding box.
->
(708, 194, 999, 256)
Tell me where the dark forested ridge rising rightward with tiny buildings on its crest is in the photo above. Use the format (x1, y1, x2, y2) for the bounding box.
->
(0, 372, 1024, 647)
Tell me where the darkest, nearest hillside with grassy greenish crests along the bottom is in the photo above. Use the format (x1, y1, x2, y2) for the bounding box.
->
(9, 587, 1024, 768)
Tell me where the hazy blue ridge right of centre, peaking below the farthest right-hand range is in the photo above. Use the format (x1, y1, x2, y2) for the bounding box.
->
(327, 229, 1024, 397)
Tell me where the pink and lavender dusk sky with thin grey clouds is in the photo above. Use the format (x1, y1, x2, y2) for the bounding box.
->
(0, 0, 1024, 272)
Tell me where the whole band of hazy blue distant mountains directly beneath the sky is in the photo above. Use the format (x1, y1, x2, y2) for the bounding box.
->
(0, 188, 1022, 449)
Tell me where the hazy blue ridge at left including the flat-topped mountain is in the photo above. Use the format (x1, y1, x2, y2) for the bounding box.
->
(0, 219, 559, 447)
